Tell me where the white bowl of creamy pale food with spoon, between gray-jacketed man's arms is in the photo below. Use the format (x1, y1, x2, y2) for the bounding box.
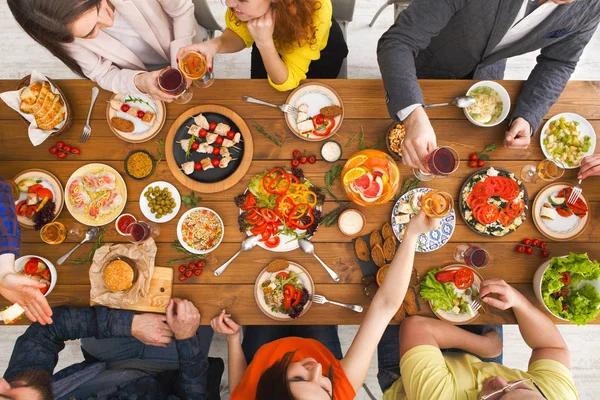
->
(464, 81, 510, 127)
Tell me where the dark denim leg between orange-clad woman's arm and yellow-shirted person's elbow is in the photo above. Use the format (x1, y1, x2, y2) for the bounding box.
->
(377, 325, 400, 393)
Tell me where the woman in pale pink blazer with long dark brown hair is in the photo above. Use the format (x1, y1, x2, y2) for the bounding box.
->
(8, 0, 207, 101)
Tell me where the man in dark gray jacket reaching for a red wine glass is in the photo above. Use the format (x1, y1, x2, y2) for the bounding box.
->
(377, 0, 600, 171)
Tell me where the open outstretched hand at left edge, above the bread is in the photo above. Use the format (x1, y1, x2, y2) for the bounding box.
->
(0, 271, 52, 325)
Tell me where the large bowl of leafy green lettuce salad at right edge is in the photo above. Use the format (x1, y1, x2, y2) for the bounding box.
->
(533, 253, 600, 325)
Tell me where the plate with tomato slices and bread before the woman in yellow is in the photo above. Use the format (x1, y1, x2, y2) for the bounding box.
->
(285, 82, 344, 142)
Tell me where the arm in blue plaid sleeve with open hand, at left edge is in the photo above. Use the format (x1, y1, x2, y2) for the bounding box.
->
(0, 177, 52, 325)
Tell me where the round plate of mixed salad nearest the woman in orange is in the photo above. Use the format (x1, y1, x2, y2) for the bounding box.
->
(254, 260, 315, 322)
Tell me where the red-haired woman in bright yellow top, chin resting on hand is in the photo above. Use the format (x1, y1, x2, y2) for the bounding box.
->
(179, 0, 348, 91)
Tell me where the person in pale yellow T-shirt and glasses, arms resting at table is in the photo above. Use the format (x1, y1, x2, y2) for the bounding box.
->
(379, 279, 578, 400)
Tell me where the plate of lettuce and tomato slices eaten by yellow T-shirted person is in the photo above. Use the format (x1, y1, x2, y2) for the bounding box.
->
(420, 264, 486, 325)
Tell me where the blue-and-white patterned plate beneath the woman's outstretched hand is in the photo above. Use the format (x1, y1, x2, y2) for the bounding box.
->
(392, 188, 456, 253)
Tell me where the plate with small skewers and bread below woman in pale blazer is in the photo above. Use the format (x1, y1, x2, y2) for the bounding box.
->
(106, 93, 167, 143)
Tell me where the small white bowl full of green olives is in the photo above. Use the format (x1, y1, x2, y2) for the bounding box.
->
(140, 181, 181, 223)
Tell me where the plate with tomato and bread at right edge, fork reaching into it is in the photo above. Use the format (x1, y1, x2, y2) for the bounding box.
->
(533, 183, 590, 241)
